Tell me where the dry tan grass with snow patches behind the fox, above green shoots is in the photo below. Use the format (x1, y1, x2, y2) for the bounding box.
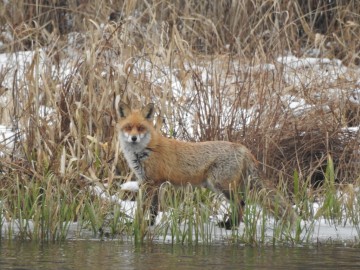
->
(0, 0, 360, 242)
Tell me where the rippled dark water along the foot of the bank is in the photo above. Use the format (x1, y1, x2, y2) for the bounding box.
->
(0, 241, 360, 270)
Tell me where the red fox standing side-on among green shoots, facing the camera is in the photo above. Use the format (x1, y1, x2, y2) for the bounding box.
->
(115, 102, 297, 229)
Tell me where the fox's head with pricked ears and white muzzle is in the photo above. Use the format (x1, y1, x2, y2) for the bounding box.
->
(117, 102, 155, 151)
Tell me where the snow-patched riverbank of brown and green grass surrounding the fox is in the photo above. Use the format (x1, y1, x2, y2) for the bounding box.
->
(0, 0, 360, 244)
